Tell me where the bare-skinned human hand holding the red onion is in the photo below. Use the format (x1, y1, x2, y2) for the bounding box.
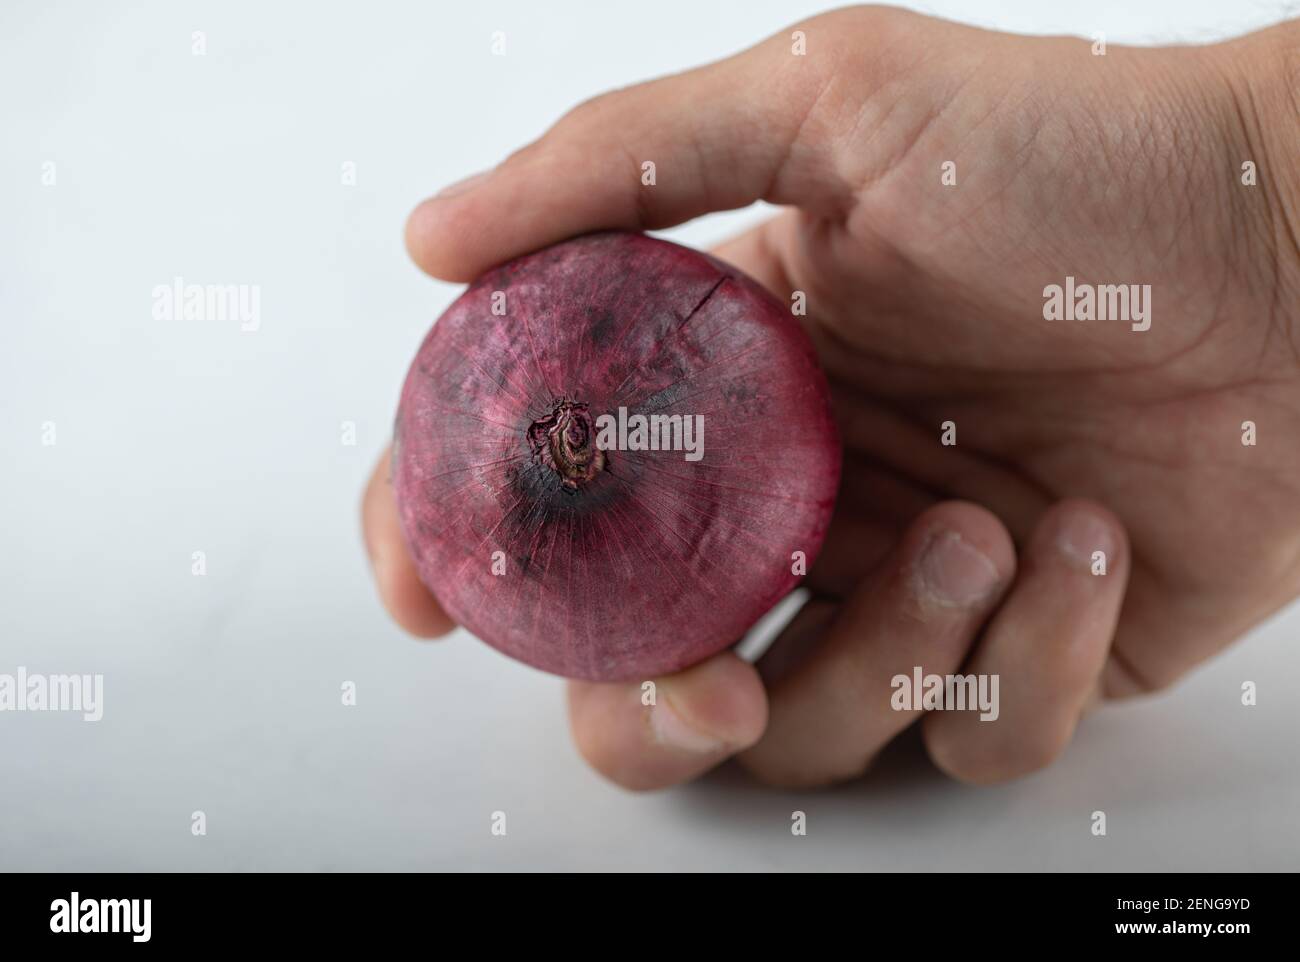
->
(363, 7, 1300, 789)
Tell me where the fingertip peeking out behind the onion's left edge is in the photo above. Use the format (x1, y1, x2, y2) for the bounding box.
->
(361, 449, 456, 638)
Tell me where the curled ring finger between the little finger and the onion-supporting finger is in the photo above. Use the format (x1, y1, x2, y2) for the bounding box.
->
(741, 502, 1015, 785)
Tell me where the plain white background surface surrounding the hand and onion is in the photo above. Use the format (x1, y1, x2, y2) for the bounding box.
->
(0, 0, 1300, 870)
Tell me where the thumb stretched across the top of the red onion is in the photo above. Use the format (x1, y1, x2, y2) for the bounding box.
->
(407, 27, 852, 281)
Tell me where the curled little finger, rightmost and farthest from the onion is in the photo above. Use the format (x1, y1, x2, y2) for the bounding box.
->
(923, 501, 1130, 783)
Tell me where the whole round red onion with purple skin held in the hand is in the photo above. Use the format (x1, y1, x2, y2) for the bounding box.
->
(393, 231, 840, 681)
